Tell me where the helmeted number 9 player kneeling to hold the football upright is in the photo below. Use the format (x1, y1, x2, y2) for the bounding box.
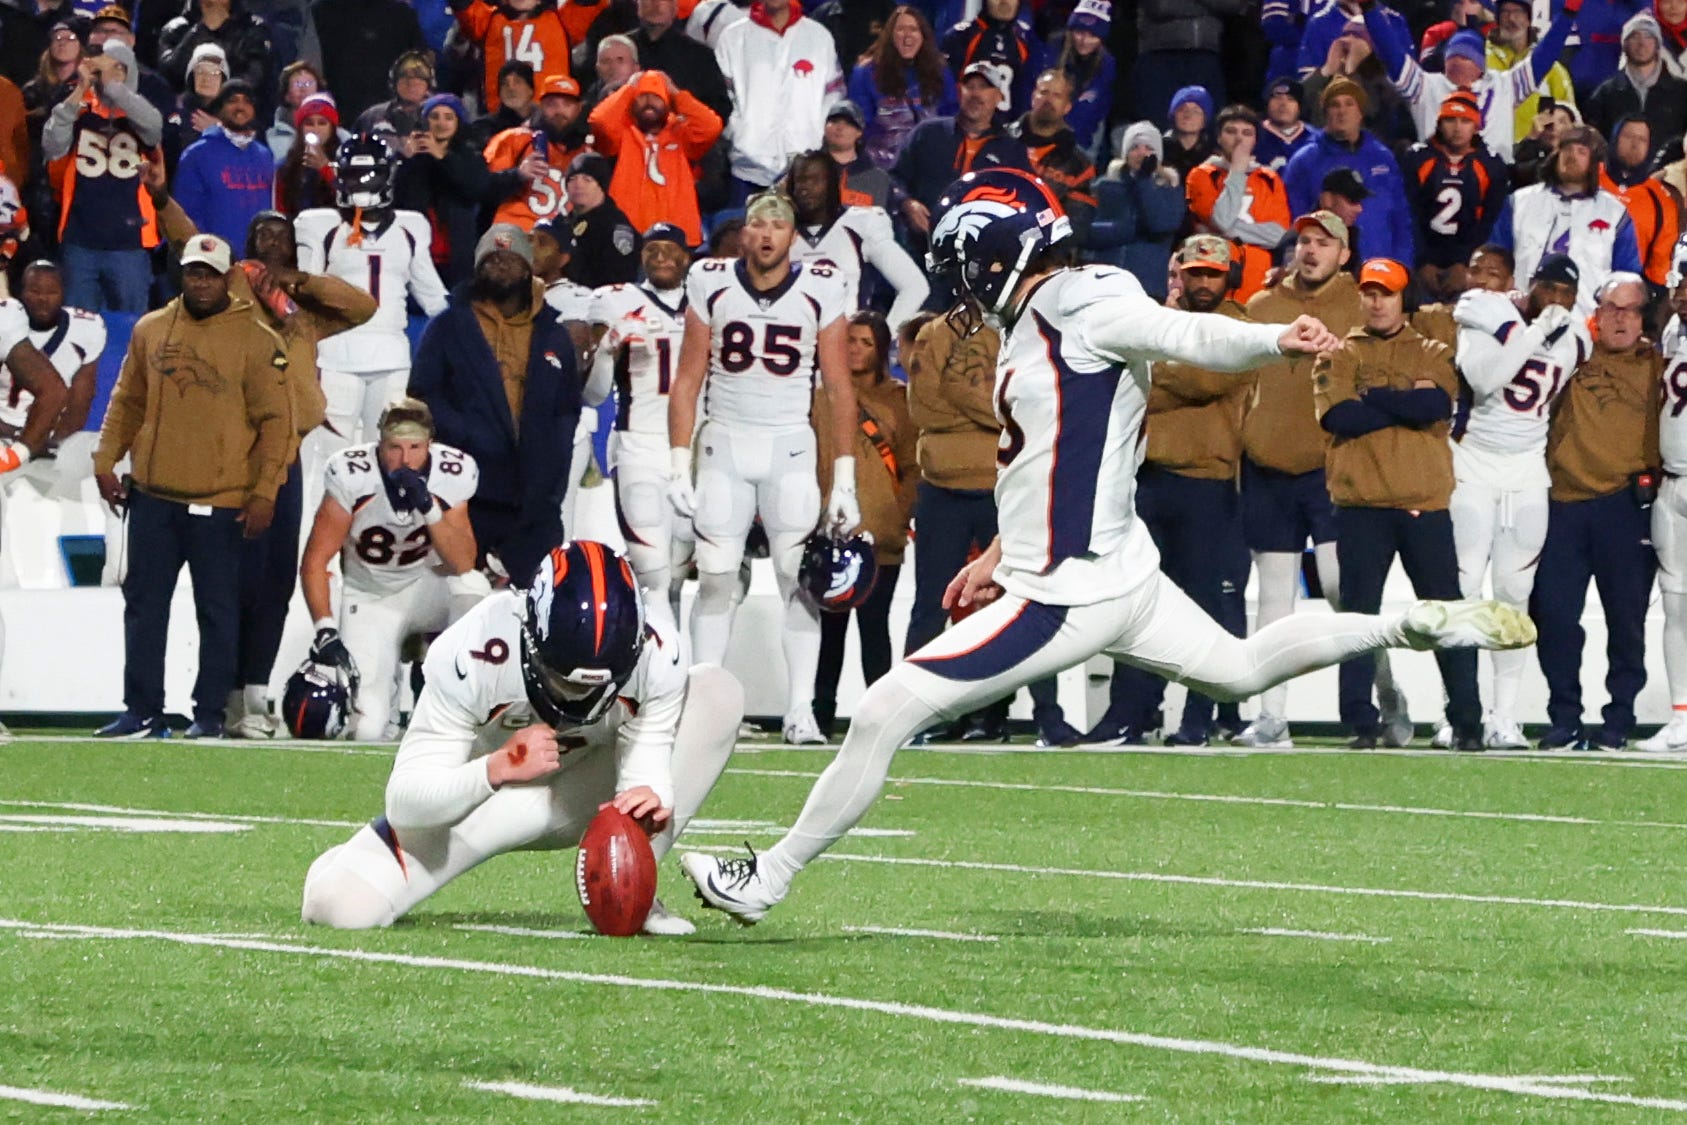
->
(304, 543, 744, 934)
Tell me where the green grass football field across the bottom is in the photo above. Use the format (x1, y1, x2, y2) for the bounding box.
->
(0, 739, 1687, 1122)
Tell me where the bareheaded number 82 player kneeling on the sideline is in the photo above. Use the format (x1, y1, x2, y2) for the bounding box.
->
(299, 398, 481, 740)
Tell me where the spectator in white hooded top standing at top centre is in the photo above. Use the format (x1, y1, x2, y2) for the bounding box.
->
(715, 0, 843, 196)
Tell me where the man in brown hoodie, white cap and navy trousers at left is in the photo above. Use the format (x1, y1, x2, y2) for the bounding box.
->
(94, 234, 294, 739)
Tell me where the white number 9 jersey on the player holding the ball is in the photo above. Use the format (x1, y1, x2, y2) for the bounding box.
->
(388, 590, 687, 820)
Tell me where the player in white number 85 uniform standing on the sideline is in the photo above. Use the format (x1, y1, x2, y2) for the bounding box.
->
(668, 191, 860, 744)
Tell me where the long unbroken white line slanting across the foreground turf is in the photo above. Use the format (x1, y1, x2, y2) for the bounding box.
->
(0, 918, 1687, 1113)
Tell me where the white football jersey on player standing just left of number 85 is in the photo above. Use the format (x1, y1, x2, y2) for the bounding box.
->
(589, 285, 687, 439)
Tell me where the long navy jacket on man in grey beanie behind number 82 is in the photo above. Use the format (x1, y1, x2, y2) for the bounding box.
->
(410, 285, 580, 580)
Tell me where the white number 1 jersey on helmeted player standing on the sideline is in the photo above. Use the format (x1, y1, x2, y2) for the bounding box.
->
(294, 207, 447, 371)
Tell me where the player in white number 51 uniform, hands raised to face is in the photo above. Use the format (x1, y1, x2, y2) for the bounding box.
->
(1447, 255, 1593, 749)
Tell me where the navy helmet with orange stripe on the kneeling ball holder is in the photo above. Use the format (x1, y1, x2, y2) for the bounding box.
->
(521, 541, 644, 729)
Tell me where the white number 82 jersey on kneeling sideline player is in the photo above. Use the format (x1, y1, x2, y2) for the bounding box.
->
(324, 442, 481, 594)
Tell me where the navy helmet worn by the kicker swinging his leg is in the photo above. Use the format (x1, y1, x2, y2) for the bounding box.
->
(926, 169, 1071, 317)
